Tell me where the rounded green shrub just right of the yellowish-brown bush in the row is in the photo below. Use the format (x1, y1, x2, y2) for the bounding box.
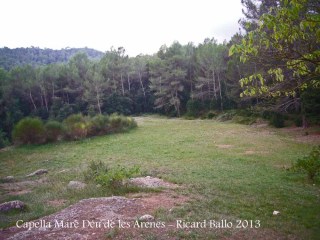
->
(88, 115, 110, 136)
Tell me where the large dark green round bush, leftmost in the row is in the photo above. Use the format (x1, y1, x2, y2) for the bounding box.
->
(12, 117, 45, 144)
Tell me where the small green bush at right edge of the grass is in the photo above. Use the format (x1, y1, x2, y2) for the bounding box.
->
(293, 146, 320, 181)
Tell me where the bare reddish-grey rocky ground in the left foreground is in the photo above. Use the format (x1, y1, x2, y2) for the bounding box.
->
(0, 176, 188, 240)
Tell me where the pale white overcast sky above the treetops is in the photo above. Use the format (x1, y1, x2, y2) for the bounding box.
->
(0, 0, 242, 56)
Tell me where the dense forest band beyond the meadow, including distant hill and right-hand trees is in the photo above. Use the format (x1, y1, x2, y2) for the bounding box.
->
(0, 0, 320, 145)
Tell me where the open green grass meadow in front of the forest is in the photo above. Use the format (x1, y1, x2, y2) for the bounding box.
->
(0, 117, 320, 239)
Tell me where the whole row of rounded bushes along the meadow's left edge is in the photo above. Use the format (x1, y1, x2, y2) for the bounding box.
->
(12, 114, 137, 144)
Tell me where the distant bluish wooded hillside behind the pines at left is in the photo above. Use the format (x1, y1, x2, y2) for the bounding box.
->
(0, 47, 104, 70)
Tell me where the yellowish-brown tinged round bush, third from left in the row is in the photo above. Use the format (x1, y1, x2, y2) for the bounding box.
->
(63, 114, 88, 140)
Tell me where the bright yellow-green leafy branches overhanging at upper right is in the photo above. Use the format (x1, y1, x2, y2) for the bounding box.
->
(229, 0, 320, 96)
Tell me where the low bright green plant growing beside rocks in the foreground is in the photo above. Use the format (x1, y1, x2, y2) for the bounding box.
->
(84, 161, 140, 188)
